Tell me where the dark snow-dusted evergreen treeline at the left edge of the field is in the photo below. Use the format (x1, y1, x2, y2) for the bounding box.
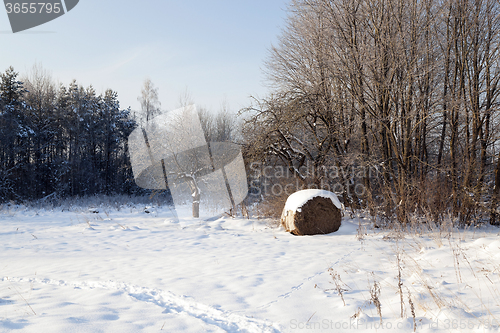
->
(0, 66, 139, 202)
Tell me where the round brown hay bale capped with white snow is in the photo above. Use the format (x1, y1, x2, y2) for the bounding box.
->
(281, 190, 342, 235)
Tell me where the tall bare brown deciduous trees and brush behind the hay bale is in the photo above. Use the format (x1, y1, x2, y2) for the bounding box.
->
(244, 0, 500, 224)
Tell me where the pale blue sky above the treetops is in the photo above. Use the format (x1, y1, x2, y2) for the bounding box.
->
(0, 0, 288, 111)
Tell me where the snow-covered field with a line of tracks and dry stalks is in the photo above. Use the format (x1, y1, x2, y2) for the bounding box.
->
(0, 206, 500, 333)
